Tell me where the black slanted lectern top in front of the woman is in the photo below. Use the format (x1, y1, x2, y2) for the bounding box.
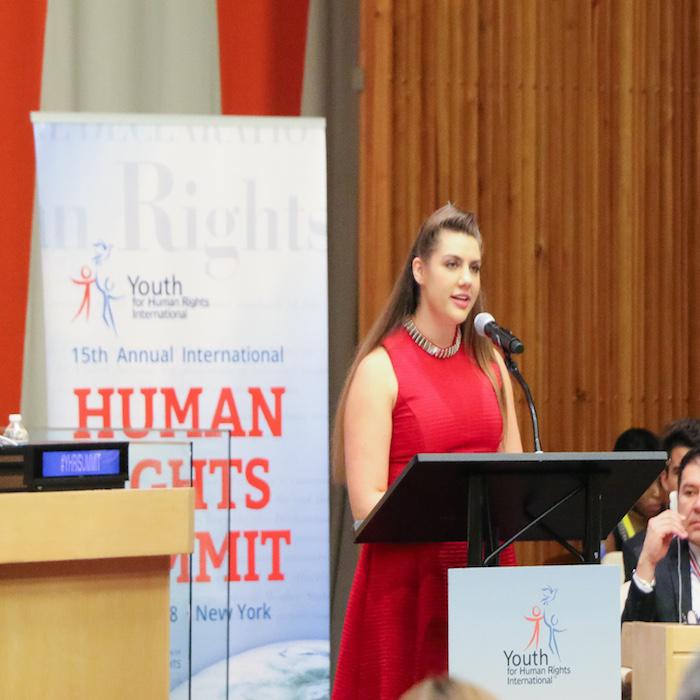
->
(355, 452, 666, 543)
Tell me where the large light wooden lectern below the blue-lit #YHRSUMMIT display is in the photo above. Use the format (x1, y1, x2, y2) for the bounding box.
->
(0, 488, 194, 700)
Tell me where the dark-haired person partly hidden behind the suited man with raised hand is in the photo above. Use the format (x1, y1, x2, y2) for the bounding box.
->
(622, 418, 700, 581)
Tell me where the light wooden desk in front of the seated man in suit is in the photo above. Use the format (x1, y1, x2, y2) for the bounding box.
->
(622, 622, 700, 700)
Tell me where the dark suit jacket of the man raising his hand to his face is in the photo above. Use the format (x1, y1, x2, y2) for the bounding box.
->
(622, 539, 692, 622)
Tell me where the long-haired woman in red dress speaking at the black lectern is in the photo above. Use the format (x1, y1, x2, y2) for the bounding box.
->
(333, 204, 522, 700)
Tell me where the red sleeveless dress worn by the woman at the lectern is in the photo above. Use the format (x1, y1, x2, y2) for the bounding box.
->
(333, 328, 515, 700)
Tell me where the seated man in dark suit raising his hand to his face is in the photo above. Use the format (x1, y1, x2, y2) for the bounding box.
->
(622, 448, 700, 622)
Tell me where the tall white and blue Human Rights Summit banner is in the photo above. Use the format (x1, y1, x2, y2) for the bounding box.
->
(34, 114, 329, 698)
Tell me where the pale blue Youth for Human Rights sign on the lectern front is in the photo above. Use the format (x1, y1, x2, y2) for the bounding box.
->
(448, 565, 620, 700)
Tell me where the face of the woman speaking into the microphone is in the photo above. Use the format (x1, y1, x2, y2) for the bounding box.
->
(413, 230, 481, 325)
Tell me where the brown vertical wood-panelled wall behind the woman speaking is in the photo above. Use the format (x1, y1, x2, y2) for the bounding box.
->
(359, 0, 700, 562)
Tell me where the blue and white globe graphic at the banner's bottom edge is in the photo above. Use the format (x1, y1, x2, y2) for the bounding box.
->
(170, 640, 330, 700)
